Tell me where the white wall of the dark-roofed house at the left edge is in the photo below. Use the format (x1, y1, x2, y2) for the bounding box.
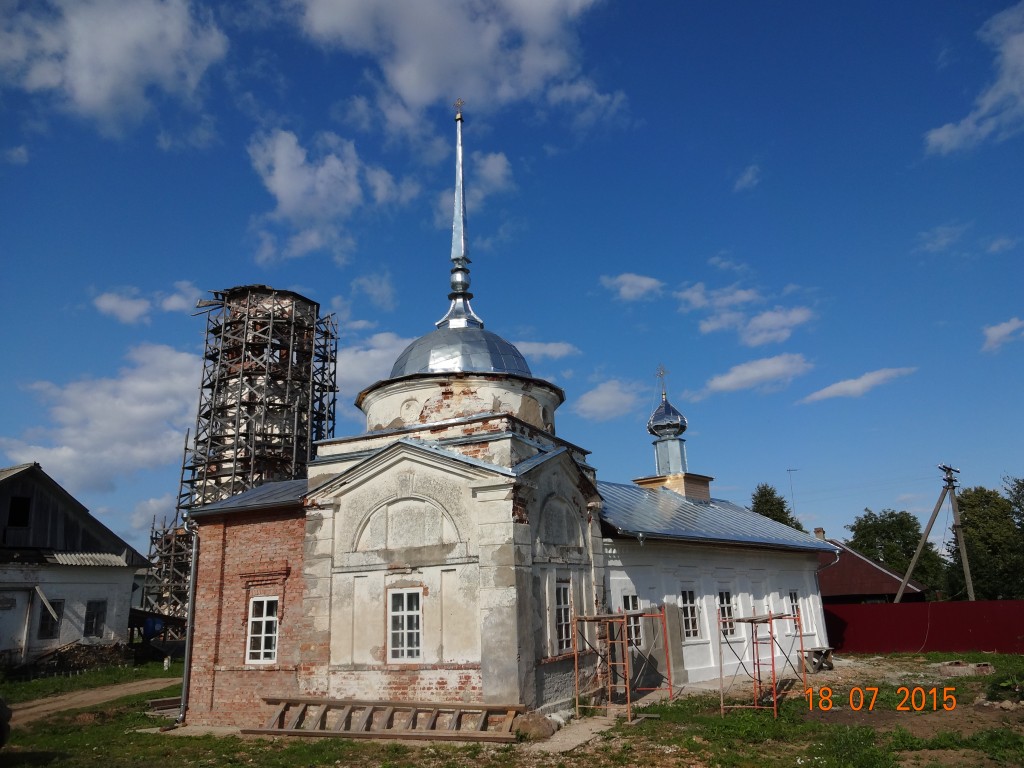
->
(0, 565, 135, 658)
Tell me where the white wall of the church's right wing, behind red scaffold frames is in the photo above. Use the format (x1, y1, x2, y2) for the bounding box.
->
(604, 539, 827, 682)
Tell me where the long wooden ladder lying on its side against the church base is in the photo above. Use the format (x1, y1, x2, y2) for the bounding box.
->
(242, 696, 526, 741)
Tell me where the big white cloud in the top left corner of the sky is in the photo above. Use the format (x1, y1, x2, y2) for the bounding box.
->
(0, 0, 227, 135)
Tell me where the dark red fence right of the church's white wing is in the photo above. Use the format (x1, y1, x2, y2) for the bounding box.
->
(824, 600, 1024, 653)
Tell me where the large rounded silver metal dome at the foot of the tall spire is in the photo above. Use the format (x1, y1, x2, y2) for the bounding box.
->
(390, 328, 534, 379)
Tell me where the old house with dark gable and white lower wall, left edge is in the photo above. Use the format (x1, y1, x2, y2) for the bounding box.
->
(0, 464, 148, 666)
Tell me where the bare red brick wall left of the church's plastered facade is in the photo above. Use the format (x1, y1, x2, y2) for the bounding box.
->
(186, 508, 306, 727)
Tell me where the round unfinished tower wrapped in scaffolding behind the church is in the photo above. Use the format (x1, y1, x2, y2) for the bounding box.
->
(142, 285, 338, 616)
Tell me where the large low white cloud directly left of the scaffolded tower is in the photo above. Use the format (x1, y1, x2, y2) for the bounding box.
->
(0, 344, 202, 493)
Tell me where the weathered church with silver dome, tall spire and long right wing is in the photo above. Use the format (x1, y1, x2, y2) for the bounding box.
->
(187, 114, 835, 727)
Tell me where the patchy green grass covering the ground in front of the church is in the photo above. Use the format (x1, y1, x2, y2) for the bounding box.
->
(6, 654, 1024, 768)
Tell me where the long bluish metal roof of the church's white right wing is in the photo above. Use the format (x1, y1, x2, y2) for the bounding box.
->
(597, 480, 836, 552)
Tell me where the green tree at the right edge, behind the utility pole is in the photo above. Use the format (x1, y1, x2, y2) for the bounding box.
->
(946, 485, 1024, 600)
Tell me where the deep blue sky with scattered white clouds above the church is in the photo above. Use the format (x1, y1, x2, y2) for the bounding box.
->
(0, 0, 1024, 551)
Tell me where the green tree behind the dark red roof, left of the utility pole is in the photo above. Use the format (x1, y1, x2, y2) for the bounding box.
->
(846, 509, 946, 591)
